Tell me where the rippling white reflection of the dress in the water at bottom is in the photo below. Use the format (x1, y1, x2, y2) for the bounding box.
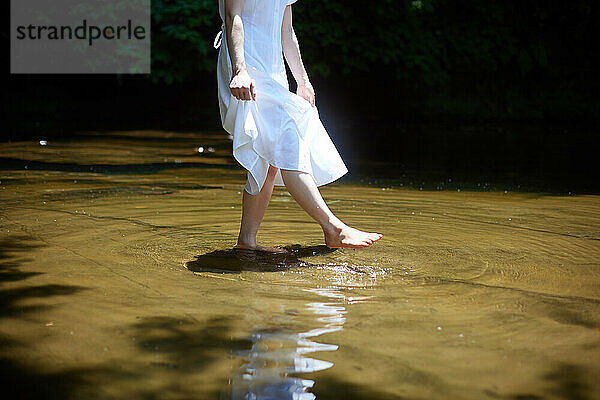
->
(232, 288, 346, 400)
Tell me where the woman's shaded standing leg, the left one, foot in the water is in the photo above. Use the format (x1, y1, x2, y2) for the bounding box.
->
(234, 165, 283, 252)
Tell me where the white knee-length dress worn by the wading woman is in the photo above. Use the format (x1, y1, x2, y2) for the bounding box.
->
(217, 0, 348, 194)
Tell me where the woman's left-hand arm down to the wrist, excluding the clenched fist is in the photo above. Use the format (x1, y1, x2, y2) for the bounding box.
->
(225, 0, 246, 75)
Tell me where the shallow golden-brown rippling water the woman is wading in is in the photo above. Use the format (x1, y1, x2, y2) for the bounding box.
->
(0, 132, 600, 399)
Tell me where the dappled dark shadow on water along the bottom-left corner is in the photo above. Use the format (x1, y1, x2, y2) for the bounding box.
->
(0, 316, 248, 400)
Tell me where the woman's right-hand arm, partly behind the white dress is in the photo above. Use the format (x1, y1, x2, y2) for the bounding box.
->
(281, 5, 315, 106)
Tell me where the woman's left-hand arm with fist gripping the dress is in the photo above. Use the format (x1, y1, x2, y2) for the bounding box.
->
(224, 0, 256, 100)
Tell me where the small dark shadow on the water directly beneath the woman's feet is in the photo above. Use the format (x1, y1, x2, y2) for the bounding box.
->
(186, 245, 336, 274)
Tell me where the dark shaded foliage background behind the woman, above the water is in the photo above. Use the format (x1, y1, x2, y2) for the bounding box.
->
(2, 0, 600, 192)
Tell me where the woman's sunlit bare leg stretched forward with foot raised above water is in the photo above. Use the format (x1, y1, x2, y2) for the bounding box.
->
(281, 169, 383, 248)
